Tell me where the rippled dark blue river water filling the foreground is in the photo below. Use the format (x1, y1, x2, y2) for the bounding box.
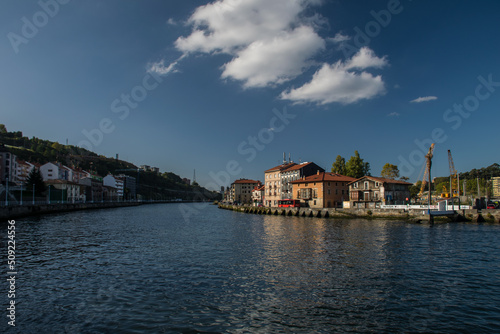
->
(0, 204, 500, 333)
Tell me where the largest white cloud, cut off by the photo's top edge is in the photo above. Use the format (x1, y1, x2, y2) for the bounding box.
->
(166, 0, 325, 88)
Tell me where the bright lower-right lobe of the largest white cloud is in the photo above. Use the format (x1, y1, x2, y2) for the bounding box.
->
(222, 26, 324, 88)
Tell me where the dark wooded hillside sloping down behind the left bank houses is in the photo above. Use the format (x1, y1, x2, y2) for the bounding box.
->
(0, 124, 218, 199)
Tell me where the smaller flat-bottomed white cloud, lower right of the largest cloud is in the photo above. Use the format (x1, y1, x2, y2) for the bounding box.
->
(281, 49, 387, 104)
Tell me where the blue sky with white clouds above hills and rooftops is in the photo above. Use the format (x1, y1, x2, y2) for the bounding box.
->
(0, 0, 500, 186)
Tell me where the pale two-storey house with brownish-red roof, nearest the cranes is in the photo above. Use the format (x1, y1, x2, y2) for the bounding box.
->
(349, 176, 412, 208)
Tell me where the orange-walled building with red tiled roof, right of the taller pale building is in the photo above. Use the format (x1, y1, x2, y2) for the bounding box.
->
(291, 171, 355, 208)
